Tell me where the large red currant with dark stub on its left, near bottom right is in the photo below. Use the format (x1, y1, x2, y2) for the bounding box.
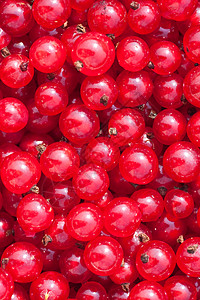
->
(136, 241, 176, 281)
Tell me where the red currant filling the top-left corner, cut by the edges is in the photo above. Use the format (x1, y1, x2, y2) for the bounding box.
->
(0, 0, 34, 36)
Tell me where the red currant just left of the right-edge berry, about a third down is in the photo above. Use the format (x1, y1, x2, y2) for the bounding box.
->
(153, 73, 183, 108)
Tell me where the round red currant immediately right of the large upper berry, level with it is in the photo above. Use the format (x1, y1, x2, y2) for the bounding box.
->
(117, 36, 150, 72)
